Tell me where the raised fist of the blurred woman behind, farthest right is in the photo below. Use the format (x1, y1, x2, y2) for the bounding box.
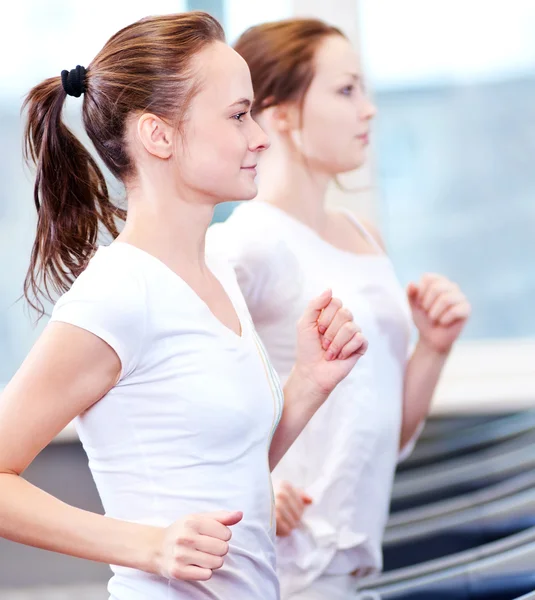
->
(407, 273, 471, 354)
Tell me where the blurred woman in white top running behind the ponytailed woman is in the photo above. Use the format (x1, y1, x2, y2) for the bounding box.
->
(209, 19, 470, 600)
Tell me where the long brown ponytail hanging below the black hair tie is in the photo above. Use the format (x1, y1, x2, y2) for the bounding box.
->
(23, 77, 125, 314)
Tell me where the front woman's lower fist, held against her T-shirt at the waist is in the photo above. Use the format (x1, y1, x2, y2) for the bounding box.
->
(155, 511, 243, 581)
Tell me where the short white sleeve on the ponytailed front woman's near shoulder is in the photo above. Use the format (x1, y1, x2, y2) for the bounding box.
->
(50, 256, 146, 379)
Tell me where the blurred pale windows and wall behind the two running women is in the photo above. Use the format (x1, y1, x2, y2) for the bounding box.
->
(0, 0, 535, 600)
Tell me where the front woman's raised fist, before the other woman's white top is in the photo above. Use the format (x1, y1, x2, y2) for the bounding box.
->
(294, 290, 368, 395)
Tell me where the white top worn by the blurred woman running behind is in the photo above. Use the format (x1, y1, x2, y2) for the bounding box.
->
(207, 201, 411, 596)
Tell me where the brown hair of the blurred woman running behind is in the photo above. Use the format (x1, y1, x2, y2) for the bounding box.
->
(234, 19, 345, 114)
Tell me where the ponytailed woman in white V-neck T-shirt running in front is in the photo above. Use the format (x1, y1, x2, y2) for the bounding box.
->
(0, 12, 366, 600)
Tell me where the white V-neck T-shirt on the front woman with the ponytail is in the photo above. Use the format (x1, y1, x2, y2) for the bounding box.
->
(52, 242, 283, 600)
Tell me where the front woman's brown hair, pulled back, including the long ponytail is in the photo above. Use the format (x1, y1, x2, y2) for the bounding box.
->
(23, 12, 224, 316)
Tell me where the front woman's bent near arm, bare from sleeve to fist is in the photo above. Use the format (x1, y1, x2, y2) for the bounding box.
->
(0, 323, 241, 580)
